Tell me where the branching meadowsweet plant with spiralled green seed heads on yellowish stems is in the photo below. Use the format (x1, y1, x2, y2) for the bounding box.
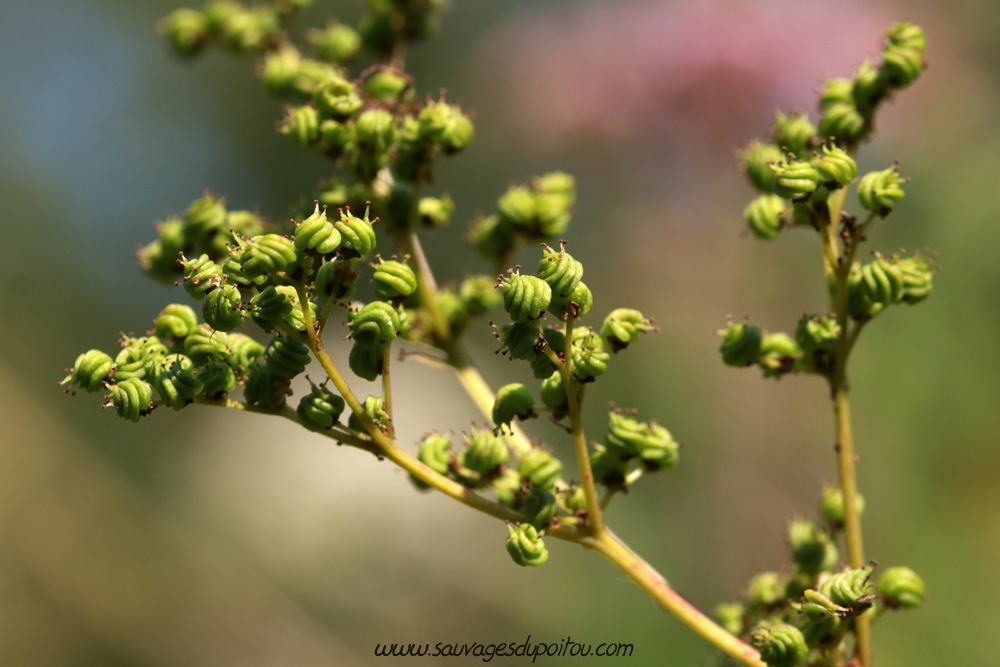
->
(62, 0, 934, 667)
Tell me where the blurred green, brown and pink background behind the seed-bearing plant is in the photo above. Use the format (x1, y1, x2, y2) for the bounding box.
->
(0, 0, 1000, 667)
